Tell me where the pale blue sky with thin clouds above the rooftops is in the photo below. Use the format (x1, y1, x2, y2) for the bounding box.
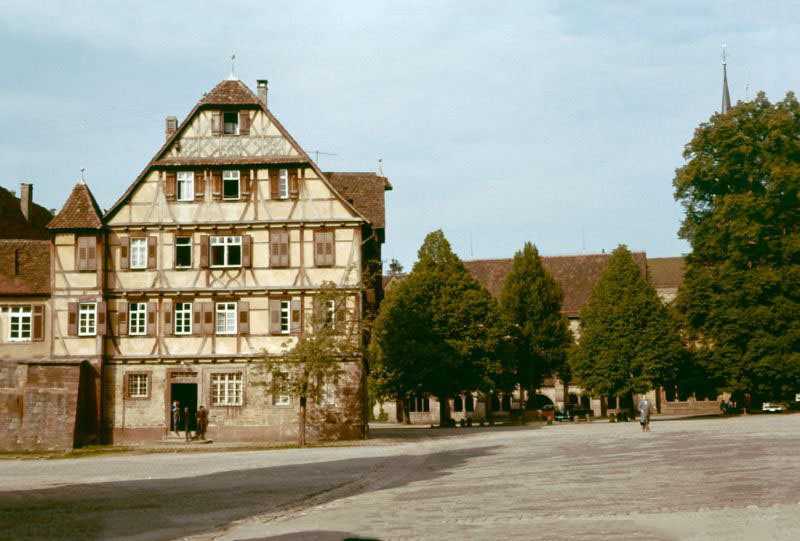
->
(0, 0, 800, 267)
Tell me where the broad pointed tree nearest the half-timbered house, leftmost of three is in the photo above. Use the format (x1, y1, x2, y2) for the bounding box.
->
(370, 231, 503, 425)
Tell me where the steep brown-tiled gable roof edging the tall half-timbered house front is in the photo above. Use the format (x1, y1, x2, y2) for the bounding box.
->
(104, 79, 367, 221)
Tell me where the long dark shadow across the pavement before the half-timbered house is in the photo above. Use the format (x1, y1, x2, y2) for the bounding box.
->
(0, 446, 495, 539)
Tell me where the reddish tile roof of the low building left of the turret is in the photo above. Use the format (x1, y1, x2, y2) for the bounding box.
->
(0, 239, 50, 295)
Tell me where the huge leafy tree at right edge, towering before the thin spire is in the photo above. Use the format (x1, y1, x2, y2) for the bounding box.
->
(674, 93, 800, 398)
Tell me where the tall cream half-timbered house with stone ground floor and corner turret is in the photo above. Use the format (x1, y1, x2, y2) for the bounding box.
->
(0, 78, 391, 448)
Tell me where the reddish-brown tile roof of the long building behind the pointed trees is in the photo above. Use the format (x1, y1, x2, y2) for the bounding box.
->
(464, 252, 647, 317)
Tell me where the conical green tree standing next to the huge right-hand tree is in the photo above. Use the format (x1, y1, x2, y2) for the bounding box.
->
(570, 245, 682, 396)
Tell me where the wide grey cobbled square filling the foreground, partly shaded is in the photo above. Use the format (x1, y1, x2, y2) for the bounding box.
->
(0, 415, 800, 541)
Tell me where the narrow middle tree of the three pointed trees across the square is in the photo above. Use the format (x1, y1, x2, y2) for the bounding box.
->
(500, 242, 572, 404)
